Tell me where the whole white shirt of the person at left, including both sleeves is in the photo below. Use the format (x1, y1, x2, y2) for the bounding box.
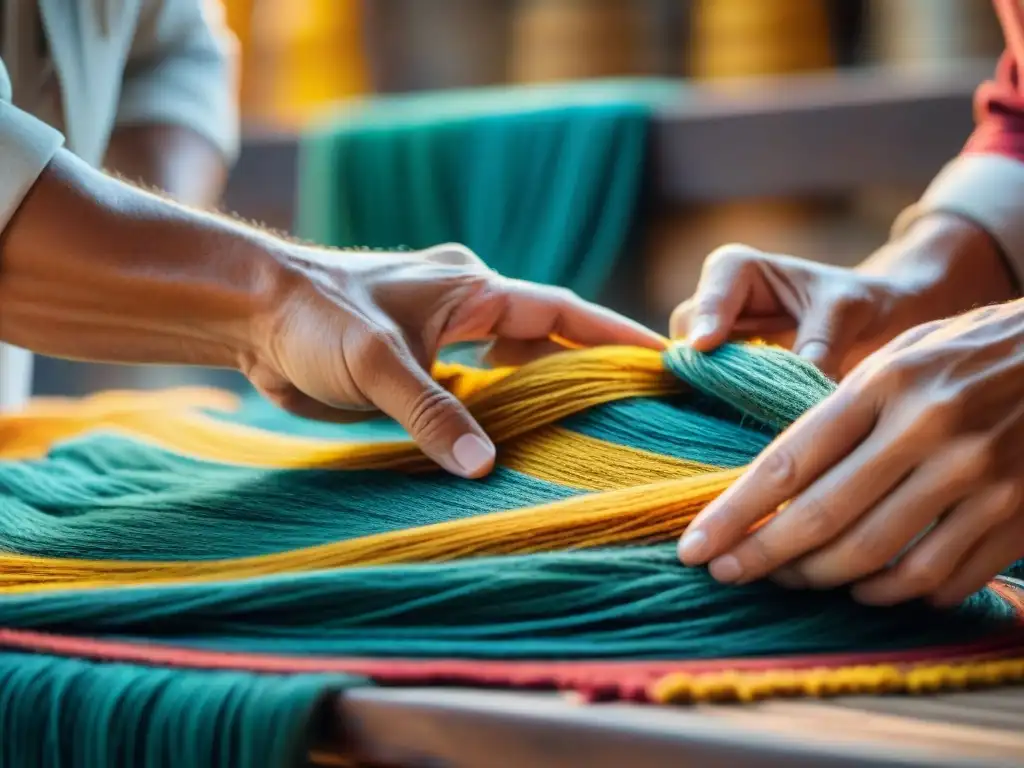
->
(0, 0, 239, 412)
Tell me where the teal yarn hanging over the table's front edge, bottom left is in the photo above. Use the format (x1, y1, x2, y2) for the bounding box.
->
(0, 653, 356, 768)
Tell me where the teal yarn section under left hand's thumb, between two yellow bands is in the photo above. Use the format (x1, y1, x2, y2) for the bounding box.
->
(0, 434, 580, 560)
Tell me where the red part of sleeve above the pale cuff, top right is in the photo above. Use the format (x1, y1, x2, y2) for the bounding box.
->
(964, 0, 1024, 161)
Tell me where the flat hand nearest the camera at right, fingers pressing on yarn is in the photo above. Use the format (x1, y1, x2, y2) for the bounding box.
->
(680, 300, 1024, 605)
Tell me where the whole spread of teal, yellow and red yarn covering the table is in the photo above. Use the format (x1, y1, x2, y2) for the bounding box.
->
(0, 344, 1024, 768)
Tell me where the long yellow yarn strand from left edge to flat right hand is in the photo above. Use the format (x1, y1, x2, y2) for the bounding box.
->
(0, 470, 741, 593)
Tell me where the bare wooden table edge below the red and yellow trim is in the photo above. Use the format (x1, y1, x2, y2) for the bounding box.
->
(334, 687, 1024, 768)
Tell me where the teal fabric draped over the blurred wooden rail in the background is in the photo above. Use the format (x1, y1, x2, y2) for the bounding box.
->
(298, 81, 676, 298)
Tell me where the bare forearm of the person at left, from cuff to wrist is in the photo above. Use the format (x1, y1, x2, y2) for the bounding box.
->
(0, 151, 284, 368)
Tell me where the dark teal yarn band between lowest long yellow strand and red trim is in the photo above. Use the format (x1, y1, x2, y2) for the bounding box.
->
(0, 544, 1013, 659)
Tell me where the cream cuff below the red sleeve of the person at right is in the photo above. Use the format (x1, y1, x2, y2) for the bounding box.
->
(893, 154, 1024, 286)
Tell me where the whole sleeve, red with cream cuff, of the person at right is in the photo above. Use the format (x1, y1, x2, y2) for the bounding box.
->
(894, 0, 1024, 288)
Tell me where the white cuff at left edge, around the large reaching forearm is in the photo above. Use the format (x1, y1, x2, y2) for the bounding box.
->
(0, 62, 63, 234)
